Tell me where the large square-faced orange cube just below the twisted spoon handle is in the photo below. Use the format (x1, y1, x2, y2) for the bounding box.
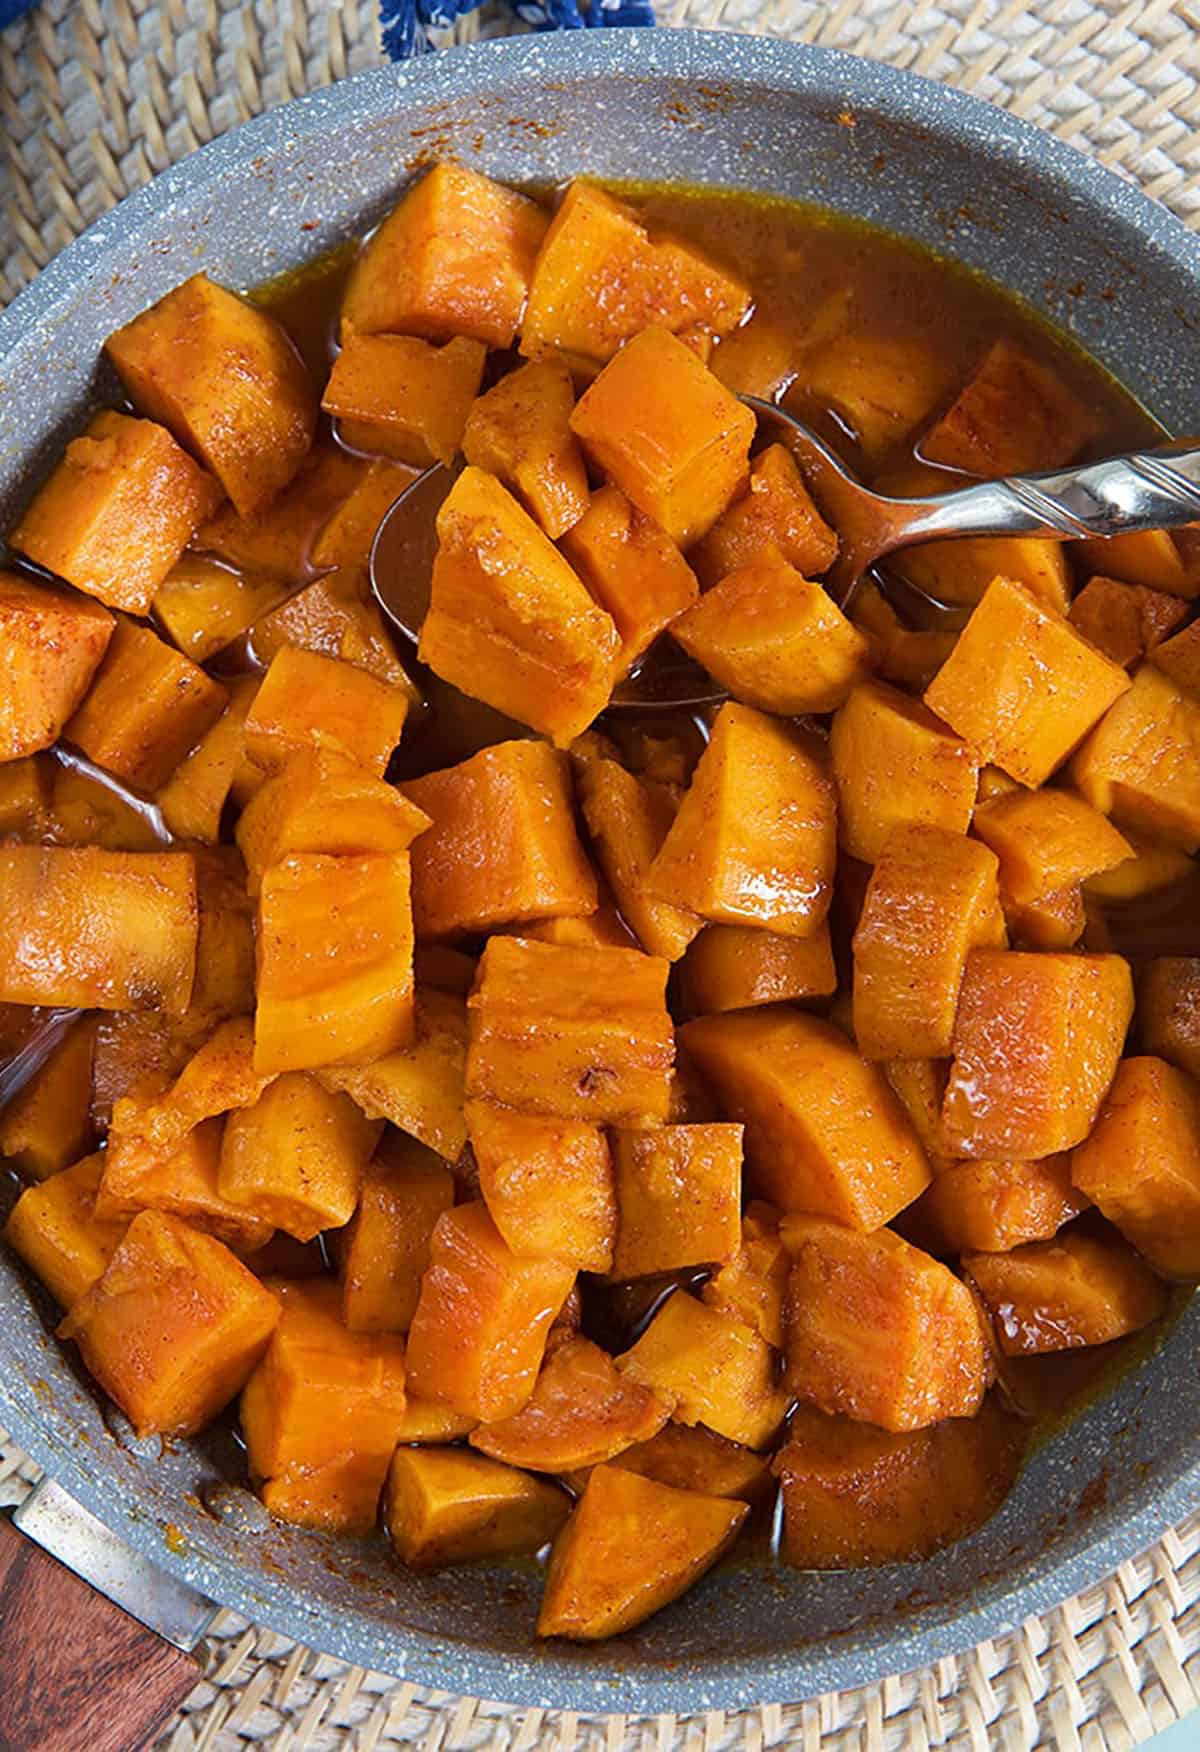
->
(925, 578, 1130, 785)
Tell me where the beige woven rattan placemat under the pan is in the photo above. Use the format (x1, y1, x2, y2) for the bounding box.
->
(0, 0, 1200, 1752)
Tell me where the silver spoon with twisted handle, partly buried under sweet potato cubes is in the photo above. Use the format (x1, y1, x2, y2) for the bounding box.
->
(370, 396, 1200, 711)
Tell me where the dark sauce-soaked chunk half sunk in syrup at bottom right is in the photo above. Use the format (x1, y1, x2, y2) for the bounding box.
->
(774, 1400, 1025, 1570)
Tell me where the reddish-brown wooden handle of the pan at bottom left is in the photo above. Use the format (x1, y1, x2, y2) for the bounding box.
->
(0, 1515, 200, 1752)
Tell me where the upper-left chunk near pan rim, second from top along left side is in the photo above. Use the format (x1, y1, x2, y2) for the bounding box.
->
(12, 408, 221, 615)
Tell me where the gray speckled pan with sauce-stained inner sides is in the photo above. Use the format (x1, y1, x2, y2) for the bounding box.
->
(0, 32, 1200, 1712)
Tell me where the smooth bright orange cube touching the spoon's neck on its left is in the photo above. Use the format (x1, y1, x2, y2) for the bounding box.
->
(571, 328, 755, 548)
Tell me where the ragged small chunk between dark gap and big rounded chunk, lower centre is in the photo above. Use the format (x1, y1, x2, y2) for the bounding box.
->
(617, 1289, 787, 1447)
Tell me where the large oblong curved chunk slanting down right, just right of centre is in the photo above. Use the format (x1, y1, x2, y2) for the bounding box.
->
(680, 1006, 928, 1230)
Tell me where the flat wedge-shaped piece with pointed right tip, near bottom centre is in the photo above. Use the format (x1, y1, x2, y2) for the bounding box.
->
(469, 1337, 671, 1473)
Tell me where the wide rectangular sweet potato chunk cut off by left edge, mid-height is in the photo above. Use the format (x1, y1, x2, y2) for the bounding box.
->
(0, 844, 198, 1016)
